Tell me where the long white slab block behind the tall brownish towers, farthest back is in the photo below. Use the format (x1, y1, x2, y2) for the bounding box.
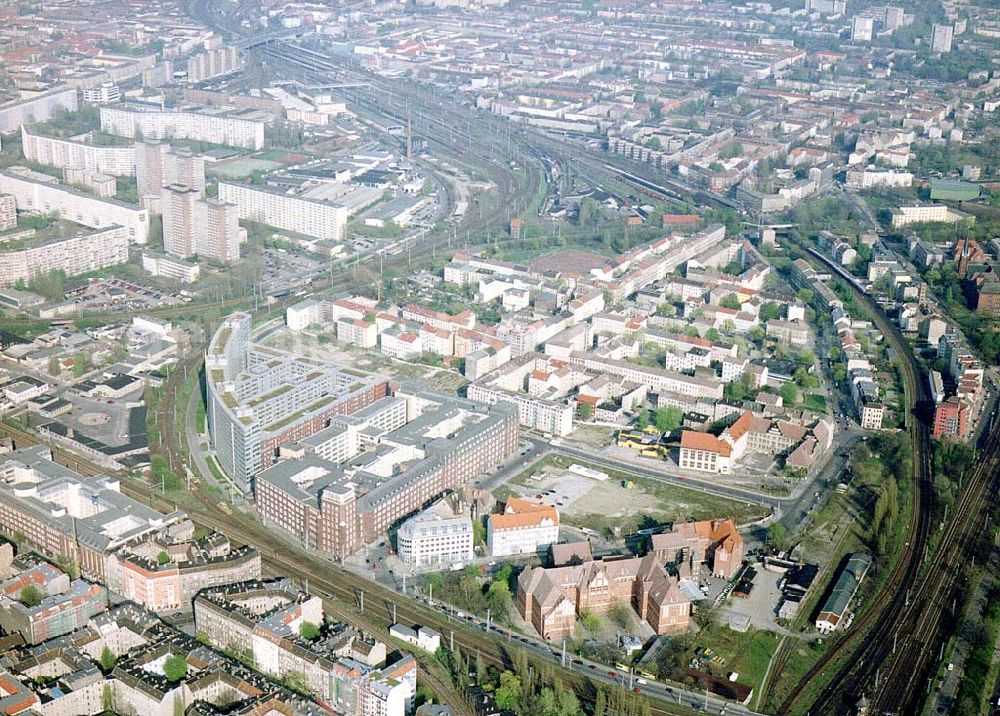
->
(101, 105, 264, 150)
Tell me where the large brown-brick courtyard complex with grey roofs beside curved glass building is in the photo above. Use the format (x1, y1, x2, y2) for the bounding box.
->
(255, 394, 518, 559)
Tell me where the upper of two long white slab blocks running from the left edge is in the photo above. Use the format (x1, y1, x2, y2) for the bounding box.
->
(0, 167, 149, 244)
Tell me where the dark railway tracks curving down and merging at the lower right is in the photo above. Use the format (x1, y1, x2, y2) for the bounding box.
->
(779, 243, 1000, 714)
